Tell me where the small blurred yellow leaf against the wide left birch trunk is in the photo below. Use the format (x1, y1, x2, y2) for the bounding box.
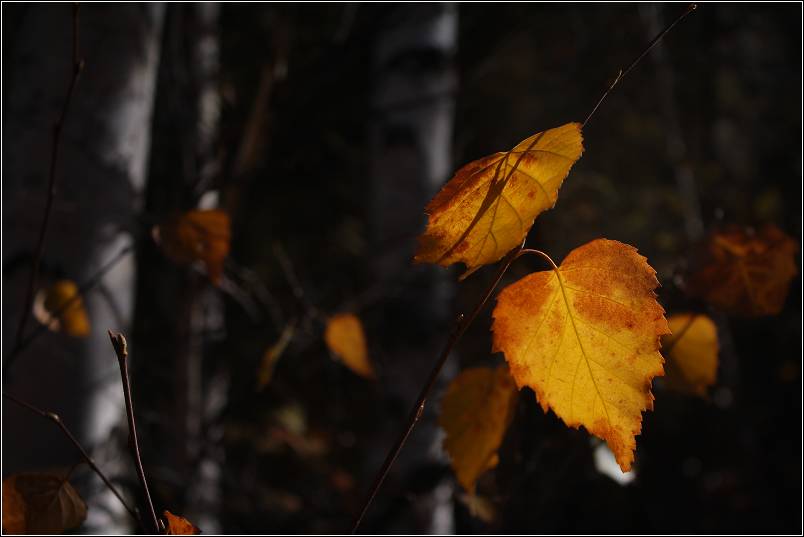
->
(33, 280, 90, 337)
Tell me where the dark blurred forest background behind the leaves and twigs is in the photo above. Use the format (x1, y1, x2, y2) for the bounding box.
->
(2, 3, 802, 534)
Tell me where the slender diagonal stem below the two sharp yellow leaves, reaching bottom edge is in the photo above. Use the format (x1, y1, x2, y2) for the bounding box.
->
(352, 240, 525, 533)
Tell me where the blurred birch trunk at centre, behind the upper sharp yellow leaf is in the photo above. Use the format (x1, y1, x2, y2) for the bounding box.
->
(366, 4, 458, 533)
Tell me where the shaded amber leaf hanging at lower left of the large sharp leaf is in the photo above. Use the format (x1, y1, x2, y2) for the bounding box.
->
(439, 365, 518, 493)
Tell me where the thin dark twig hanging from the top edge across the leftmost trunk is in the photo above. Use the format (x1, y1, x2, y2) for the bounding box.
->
(15, 3, 84, 352)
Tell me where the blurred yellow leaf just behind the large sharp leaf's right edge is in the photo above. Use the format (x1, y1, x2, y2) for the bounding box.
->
(662, 313, 718, 396)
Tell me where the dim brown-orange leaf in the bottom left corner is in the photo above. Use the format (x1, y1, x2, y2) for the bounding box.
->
(3, 474, 87, 533)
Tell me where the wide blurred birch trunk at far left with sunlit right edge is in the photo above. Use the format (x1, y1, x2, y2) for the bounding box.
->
(3, 4, 164, 530)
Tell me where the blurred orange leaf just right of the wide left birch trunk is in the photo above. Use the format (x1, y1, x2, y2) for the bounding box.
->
(154, 209, 231, 284)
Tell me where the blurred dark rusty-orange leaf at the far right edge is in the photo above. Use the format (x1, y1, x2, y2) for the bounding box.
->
(687, 225, 798, 317)
